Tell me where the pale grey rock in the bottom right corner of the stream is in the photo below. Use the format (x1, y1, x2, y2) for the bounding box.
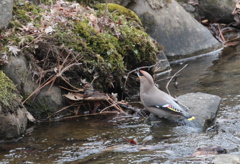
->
(212, 154, 240, 164)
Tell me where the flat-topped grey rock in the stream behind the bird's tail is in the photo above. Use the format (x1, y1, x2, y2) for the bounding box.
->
(177, 92, 221, 129)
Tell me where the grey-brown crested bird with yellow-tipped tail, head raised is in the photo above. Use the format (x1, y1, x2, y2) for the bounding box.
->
(136, 70, 195, 121)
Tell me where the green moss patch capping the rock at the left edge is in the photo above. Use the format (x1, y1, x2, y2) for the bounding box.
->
(0, 71, 17, 108)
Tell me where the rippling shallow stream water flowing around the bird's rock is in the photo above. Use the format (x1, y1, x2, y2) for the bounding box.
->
(0, 47, 240, 164)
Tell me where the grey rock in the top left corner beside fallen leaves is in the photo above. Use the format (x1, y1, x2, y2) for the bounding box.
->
(0, 0, 13, 28)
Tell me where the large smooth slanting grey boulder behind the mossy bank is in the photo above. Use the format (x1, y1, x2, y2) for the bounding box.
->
(128, 0, 220, 59)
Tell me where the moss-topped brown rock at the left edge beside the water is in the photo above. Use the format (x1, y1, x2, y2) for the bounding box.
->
(0, 71, 27, 140)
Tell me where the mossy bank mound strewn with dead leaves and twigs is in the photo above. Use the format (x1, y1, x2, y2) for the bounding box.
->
(0, 1, 159, 119)
